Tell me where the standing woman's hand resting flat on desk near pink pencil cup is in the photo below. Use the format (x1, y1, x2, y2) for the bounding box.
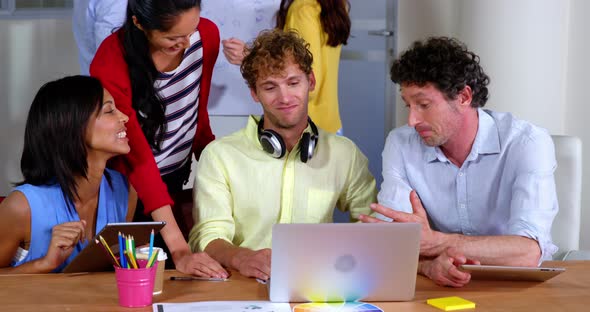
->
(174, 252, 229, 278)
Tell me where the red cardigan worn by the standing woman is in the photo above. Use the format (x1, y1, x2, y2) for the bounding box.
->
(90, 18, 219, 214)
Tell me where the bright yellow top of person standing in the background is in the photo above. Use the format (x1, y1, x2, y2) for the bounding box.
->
(284, 0, 342, 133)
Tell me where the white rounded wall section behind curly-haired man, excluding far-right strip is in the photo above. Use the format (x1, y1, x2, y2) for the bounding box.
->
(397, 0, 569, 134)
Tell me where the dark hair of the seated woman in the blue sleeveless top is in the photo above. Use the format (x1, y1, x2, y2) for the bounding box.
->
(17, 76, 103, 206)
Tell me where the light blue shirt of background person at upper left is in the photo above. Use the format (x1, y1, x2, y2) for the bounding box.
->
(72, 0, 127, 75)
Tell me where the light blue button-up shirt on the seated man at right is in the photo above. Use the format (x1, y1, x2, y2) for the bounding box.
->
(378, 109, 558, 260)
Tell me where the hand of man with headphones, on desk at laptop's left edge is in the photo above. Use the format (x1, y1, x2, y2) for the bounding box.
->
(232, 248, 271, 280)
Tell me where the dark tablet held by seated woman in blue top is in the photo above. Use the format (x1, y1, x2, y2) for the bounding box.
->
(62, 221, 166, 273)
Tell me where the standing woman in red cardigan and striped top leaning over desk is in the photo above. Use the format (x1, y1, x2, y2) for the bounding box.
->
(90, 0, 227, 277)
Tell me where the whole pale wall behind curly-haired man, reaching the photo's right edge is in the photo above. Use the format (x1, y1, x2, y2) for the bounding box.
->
(396, 0, 590, 249)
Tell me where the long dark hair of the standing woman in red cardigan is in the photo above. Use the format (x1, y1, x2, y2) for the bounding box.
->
(119, 0, 201, 150)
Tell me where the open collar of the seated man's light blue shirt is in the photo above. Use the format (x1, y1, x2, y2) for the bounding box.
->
(422, 108, 500, 162)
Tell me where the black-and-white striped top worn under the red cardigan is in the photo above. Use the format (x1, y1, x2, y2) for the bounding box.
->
(152, 31, 203, 175)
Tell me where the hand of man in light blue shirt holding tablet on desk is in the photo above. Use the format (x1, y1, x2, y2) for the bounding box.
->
(418, 248, 480, 287)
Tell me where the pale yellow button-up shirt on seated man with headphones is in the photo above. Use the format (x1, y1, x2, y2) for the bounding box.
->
(189, 116, 377, 251)
